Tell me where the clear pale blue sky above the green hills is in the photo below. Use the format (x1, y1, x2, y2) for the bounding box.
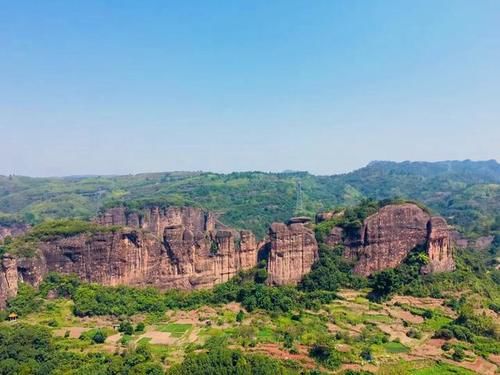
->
(0, 0, 500, 176)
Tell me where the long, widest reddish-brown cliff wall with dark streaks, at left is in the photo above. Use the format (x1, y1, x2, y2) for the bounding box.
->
(0, 207, 257, 301)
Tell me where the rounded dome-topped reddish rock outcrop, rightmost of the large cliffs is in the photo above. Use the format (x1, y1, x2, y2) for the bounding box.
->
(340, 203, 455, 276)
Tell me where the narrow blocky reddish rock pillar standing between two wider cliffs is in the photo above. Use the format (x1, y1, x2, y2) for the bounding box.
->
(267, 223, 318, 285)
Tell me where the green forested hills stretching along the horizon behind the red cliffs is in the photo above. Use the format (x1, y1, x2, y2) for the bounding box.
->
(0, 161, 500, 236)
